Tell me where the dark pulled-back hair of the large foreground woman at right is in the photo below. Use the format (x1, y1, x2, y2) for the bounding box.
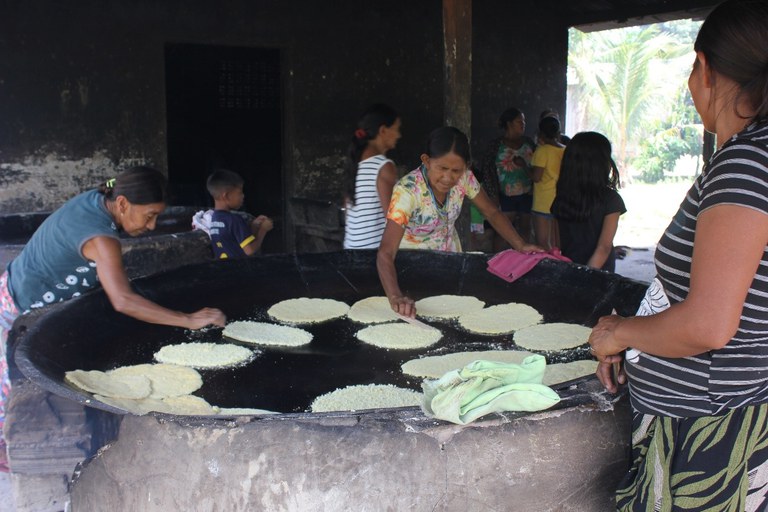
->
(693, 0, 768, 120)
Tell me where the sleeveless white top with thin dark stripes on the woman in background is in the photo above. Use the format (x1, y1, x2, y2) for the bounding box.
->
(344, 155, 392, 249)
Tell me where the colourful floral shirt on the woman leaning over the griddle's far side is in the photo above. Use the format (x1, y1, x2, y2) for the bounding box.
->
(387, 166, 480, 252)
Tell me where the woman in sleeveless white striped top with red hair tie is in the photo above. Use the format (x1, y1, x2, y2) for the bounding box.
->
(344, 103, 400, 249)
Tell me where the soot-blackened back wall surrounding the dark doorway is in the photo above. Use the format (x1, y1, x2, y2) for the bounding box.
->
(0, 0, 566, 250)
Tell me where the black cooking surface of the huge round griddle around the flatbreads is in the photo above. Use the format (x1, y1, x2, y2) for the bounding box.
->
(10, 250, 646, 412)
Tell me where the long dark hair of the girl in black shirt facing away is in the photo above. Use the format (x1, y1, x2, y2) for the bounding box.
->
(552, 132, 619, 221)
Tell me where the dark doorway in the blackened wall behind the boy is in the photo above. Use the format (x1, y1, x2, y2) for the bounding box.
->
(165, 44, 285, 252)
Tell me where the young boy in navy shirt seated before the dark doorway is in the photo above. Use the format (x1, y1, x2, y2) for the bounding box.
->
(206, 169, 273, 259)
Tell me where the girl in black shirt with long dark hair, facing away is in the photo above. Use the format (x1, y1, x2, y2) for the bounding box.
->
(552, 132, 627, 272)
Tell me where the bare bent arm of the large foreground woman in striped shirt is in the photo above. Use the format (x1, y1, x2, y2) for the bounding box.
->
(589, 205, 768, 357)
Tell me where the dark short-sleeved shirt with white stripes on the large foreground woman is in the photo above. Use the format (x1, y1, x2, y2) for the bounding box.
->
(626, 122, 768, 417)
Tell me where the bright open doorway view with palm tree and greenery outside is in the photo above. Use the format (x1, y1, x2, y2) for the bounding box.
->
(565, 19, 704, 254)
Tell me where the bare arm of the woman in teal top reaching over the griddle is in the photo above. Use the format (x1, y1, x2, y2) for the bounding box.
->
(83, 236, 226, 329)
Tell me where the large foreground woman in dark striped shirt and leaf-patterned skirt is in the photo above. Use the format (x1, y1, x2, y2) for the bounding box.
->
(589, 0, 768, 511)
